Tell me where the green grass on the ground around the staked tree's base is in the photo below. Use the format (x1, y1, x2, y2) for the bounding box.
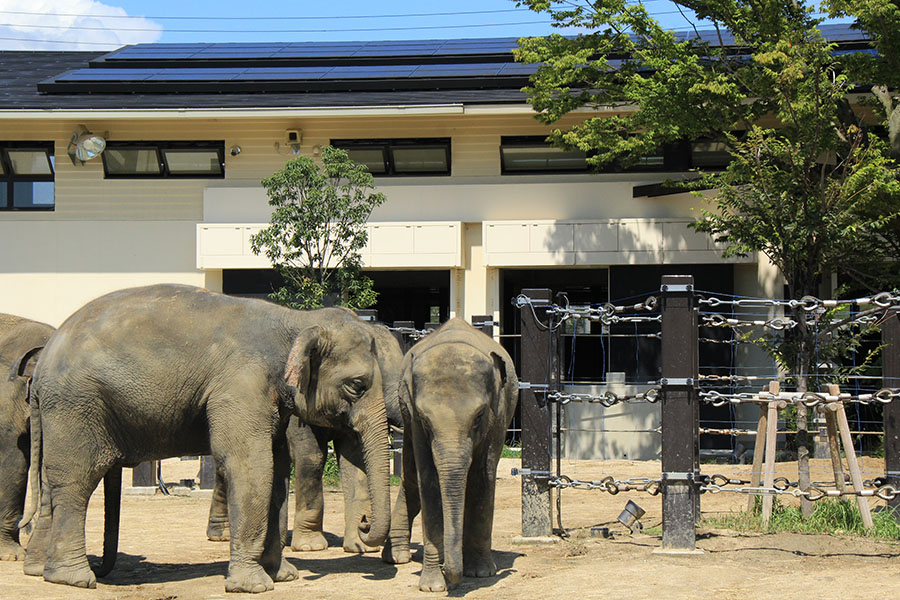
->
(704, 498, 900, 541)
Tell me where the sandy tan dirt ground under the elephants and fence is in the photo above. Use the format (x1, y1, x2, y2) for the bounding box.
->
(0, 459, 900, 600)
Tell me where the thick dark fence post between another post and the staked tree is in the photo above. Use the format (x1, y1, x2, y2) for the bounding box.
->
(660, 275, 700, 552)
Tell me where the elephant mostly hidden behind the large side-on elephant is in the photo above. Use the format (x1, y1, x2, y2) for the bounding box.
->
(206, 324, 403, 553)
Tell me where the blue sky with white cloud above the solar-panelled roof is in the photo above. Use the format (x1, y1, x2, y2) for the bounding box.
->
(0, 0, 844, 50)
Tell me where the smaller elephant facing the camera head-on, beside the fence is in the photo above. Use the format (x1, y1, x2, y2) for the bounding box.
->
(382, 318, 519, 592)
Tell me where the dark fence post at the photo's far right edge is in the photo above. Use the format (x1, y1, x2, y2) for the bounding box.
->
(881, 309, 900, 520)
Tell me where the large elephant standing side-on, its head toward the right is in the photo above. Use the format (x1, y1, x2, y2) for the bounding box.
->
(25, 285, 390, 592)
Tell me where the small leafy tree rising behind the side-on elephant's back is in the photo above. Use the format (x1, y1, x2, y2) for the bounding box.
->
(250, 146, 386, 309)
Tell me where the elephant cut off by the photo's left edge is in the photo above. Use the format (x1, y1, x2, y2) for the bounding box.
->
(0, 314, 55, 560)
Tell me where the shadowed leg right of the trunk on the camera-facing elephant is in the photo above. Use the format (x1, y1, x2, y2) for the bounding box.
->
(463, 452, 499, 577)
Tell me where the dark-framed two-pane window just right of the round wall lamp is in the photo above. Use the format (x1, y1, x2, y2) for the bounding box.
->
(101, 141, 225, 179)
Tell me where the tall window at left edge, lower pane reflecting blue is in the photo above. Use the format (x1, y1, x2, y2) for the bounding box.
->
(0, 142, 55, 210)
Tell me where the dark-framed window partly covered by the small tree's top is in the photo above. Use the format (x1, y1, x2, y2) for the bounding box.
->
(331, 138, 450, 176)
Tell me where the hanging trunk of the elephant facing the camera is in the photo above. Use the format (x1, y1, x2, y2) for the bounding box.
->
(433, 438, 472, 587)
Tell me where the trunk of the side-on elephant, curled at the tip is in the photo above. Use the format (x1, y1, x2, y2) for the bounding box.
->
(354, 390, 391, 546)
